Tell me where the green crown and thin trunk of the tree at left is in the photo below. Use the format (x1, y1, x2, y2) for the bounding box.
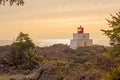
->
(12, 32, 35, 64)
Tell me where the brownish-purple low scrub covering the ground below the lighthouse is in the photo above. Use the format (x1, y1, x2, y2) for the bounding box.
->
(0, 44, 120, 80)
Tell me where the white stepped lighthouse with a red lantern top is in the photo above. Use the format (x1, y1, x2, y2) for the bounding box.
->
(70, 25, 93, 49)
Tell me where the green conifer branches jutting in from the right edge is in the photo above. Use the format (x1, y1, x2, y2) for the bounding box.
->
(102, 12, 120, 57)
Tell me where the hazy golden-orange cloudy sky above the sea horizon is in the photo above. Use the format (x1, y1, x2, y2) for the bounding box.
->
(0, 0, 120, 45)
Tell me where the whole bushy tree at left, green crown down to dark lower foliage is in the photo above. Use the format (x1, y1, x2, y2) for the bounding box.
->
(7, 32, 41, 69)
